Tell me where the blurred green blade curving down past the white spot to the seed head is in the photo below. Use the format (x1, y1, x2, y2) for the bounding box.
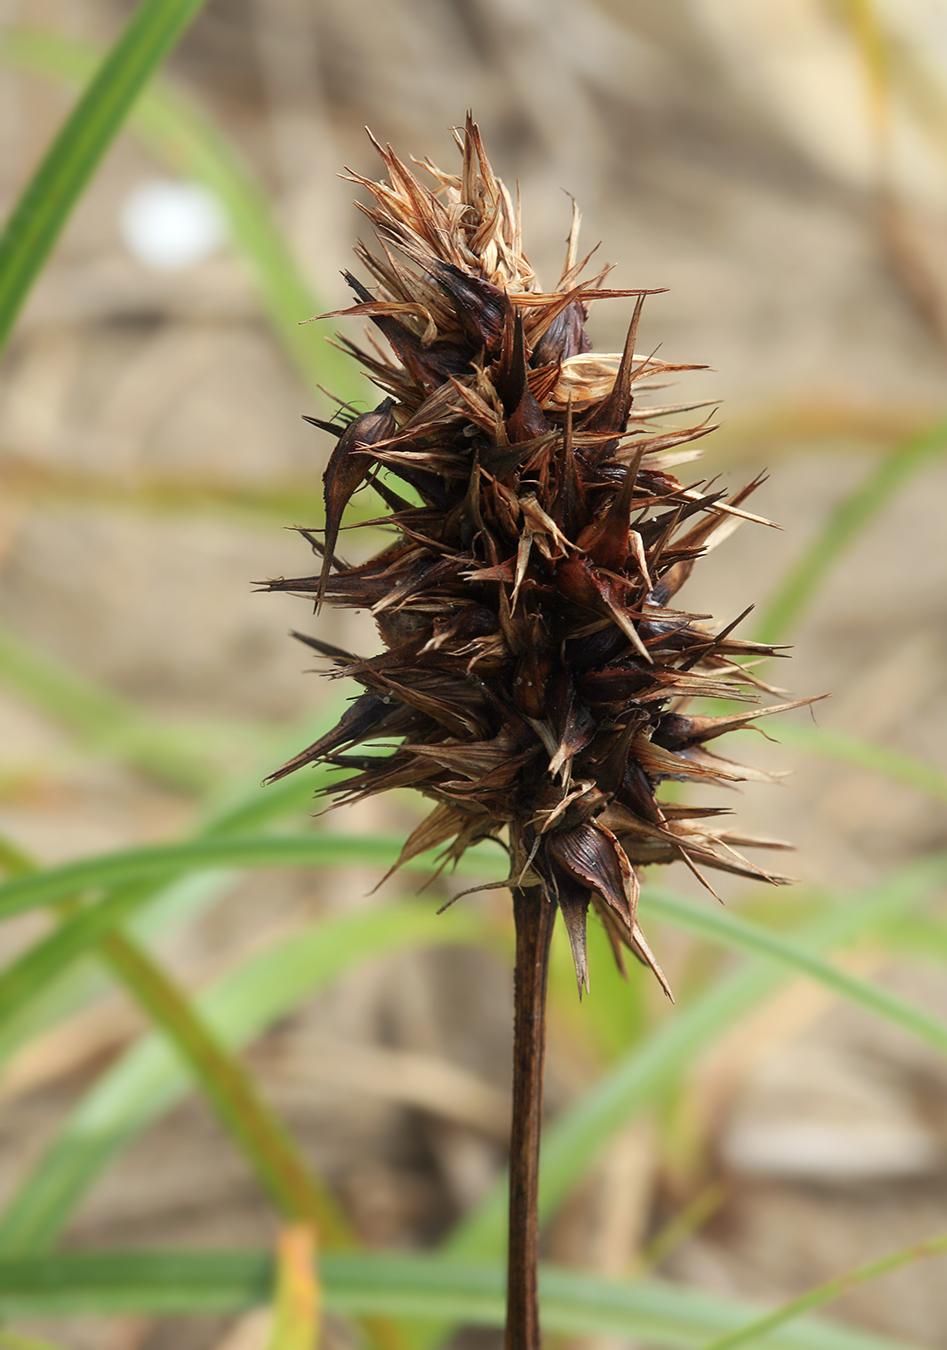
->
(0, 28, 370, 402)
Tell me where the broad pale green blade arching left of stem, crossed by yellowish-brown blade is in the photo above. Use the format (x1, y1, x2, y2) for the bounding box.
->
(0, 903, 478, 1253)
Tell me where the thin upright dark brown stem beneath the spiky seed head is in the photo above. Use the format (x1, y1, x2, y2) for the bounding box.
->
(507, 888, 555, 1350)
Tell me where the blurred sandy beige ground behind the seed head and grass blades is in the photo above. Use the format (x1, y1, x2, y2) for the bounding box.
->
(0, 0, 947, 1350)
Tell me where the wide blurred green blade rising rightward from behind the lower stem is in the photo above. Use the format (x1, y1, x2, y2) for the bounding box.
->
(443, 855, 947, 1263)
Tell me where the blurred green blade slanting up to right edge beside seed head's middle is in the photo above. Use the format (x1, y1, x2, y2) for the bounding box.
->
(752, 421, 947, 643)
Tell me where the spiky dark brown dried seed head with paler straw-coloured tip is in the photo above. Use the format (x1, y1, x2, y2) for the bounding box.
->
(269, 117, 805, 990)
